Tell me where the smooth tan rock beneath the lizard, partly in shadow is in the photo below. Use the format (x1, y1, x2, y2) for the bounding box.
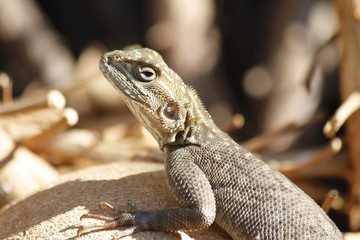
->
(0, 161, 230, 240)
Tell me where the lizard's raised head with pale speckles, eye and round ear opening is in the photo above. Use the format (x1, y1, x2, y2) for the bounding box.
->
(100, 48, 191, 148)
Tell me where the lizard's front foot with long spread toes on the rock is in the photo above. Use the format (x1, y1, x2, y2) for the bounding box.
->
(77, 201, 137, 239)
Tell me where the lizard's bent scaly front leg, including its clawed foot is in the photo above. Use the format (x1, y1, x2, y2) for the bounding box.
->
(78, 148, 216, 239)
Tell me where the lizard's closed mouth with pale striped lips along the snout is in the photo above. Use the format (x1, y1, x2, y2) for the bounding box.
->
(99, 54, 147, 105)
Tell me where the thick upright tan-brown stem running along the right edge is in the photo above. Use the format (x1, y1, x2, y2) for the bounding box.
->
(335, 0, 360, 230)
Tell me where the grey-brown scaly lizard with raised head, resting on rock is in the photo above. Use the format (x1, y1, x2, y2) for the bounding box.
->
(77, 48, 343, 240)
